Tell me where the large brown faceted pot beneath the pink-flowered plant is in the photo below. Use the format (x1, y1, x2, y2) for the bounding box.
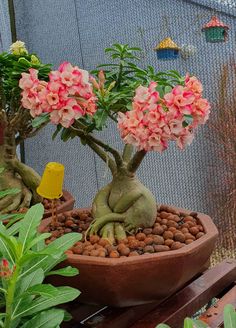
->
(40, 208, 218, 307)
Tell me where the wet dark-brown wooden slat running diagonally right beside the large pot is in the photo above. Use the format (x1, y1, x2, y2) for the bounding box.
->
(130, 260, 236, 328)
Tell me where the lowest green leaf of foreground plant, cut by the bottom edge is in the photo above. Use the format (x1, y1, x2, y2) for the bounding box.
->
(21, 309, 64, 328)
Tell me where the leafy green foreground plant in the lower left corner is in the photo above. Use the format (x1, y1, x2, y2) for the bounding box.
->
(0, 204, 81, 328)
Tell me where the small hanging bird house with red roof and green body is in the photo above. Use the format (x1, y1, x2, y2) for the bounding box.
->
(202, 16, 229, 42)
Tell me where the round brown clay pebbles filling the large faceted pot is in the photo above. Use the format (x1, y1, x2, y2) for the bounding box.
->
(45, 205, 205, 258)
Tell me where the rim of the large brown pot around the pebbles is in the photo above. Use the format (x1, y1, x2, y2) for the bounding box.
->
(42, 206, 219, 266)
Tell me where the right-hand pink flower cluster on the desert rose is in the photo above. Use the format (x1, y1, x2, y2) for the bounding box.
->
(118, 75, 210, 152)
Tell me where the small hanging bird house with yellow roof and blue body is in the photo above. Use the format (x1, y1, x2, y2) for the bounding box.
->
(154, 38, 180, 60)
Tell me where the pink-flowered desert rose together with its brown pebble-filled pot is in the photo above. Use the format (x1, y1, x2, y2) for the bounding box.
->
(20, 44, 217, 306)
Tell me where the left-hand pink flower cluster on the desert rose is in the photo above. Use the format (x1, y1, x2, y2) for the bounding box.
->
(19, 62, 96, 128)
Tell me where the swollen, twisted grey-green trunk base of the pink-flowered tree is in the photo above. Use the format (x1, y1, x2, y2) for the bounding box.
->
(89, 170, 157, 243)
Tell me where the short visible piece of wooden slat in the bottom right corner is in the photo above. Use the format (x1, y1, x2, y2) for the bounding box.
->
(200, 285, 236, 328)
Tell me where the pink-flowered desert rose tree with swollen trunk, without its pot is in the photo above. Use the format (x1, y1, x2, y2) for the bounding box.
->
(20, 44, 210, 243)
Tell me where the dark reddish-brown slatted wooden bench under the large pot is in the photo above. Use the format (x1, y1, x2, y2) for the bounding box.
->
(63, 259, 236, 328)
